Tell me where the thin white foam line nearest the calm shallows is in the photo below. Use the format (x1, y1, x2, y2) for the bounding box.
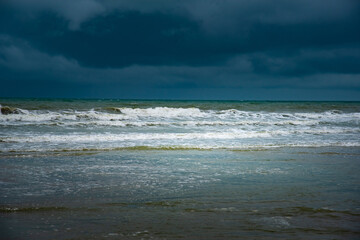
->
(0, 128, 360, 143)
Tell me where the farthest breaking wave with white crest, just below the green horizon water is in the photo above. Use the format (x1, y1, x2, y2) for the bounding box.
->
(0, 107, 360, 126)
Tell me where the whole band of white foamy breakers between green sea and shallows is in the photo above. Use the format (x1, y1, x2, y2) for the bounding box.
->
(0, 107, 360, 151)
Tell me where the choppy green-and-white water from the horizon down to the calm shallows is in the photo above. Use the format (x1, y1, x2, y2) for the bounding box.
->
(0, 100, 360, 153)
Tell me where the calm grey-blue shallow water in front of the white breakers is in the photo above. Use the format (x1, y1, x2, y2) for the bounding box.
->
(0, 148, 360, 239)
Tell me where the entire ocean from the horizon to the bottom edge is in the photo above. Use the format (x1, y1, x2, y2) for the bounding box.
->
(0, 98, 360, 239)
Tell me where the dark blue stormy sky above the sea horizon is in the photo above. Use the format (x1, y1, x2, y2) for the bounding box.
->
(0, 0, 360, 101)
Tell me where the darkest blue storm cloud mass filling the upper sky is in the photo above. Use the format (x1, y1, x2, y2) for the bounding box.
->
(2, 0, 360, 68)
